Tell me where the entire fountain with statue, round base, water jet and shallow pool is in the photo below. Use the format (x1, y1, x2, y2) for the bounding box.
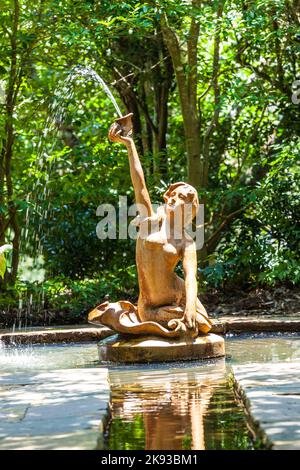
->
(0, 61, 300, 451)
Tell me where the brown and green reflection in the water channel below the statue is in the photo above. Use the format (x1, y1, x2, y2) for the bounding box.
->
(107, 359, 251, 450)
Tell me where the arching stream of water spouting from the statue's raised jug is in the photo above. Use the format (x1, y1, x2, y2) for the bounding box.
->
(14, 66, 122, 329)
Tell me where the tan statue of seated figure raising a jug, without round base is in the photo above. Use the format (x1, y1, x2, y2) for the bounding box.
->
(88, 114, 212, 338)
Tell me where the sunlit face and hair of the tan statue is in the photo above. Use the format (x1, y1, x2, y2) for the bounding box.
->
(165, 185, 195, 225)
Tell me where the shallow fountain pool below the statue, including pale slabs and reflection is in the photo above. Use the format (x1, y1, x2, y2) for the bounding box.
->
(0, 329, 300, 450)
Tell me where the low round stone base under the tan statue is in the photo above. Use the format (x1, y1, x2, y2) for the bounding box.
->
(98, 333, 225, 363)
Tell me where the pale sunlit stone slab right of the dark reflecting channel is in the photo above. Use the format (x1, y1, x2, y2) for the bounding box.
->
(232, 362, 300, 450)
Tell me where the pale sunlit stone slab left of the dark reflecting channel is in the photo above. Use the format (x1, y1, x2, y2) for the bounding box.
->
(0, 368, 110, 450)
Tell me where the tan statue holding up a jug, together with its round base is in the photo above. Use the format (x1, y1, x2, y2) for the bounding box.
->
(88, 113, 225, 362)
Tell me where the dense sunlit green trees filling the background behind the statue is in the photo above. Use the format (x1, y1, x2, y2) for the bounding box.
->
(0, 0, 300, 300)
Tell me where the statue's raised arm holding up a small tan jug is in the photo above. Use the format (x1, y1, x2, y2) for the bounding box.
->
(108, 113, 154, 217)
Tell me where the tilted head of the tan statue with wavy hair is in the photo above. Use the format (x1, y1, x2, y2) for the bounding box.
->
(164, 181, 199, 226)
